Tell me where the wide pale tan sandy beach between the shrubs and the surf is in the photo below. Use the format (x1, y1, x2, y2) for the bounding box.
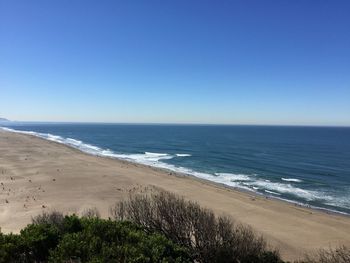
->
(0, 131, 350, 260)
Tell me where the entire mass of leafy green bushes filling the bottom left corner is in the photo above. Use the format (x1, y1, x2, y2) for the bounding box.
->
(0, 214, 191, 262)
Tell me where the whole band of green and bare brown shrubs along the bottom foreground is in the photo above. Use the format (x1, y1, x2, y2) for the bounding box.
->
(0, 191, 350, 263)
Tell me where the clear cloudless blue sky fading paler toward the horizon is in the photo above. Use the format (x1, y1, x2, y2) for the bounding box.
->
(0, 0, 350, 126)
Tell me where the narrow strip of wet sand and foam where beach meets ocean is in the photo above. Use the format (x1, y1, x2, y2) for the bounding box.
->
(0, 126, 350, 217)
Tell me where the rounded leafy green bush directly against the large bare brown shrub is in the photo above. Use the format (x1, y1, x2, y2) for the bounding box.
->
(50, 218, 190, 262)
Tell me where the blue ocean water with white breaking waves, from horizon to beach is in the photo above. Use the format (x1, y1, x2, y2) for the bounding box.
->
(0, 123, 350, 214)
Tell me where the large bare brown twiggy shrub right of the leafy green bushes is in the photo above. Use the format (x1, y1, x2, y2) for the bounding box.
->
(111, 191, 281, 263)
